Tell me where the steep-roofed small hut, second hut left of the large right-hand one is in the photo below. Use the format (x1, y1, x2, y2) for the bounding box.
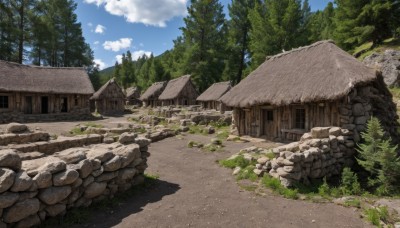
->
(158, 75, 199, 106)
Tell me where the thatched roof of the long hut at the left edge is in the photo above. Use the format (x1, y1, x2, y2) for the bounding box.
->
(0, 60, 94, 94)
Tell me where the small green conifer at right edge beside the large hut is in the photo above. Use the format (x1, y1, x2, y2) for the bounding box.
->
(357, 118, 400, 195)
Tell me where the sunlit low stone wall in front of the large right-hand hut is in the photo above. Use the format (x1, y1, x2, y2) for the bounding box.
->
(254, 127, 355, 187)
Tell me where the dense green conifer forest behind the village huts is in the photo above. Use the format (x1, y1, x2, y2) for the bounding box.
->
(0, 0, 400, 92)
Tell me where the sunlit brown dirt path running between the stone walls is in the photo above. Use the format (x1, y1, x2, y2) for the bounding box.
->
(76, 135, 370, 228)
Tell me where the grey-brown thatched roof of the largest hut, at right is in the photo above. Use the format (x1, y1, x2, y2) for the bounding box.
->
(221, 41, 376, 107)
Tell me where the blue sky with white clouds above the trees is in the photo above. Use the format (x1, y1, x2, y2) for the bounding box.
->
(76, 0, 329, 69)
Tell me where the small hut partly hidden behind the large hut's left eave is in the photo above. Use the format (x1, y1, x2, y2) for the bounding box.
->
(197, 82, 232, 111)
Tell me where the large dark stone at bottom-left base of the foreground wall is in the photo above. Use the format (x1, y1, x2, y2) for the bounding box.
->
(3, 198, 40, 223)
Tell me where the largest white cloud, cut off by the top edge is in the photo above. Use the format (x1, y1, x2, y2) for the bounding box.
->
(84, 0, 187, 27)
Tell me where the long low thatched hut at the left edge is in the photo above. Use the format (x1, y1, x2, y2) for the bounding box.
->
(0, 61, 94, 123)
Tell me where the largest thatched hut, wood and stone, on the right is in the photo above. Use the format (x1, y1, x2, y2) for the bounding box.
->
(221, 41, 399, 142)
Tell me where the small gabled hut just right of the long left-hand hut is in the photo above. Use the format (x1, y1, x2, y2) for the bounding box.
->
(90, 78, 126, 115)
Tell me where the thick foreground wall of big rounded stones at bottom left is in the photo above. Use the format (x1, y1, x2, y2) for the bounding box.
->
(0, 125, 150, 227)
